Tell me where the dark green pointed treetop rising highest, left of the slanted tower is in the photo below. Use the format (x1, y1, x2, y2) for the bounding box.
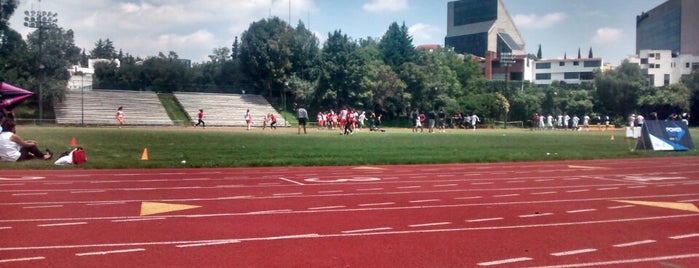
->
(379, 22, 415, 70)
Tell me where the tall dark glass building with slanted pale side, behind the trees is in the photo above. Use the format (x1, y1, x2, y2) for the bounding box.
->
(444, 0, 526, 58)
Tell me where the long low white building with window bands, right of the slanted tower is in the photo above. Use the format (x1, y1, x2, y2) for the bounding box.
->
(531, 58, 604, 85)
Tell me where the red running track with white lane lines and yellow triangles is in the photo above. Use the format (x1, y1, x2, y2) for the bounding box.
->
(0, 157, 699, 267)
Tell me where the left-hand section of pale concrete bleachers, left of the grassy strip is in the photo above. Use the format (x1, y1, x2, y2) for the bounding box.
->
(54, 90, 173, 126)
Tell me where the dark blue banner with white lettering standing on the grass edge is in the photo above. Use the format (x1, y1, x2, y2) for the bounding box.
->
(636, 120, 694, 151)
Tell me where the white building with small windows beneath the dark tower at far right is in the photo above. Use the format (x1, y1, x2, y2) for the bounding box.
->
(627, 50, 699, 87)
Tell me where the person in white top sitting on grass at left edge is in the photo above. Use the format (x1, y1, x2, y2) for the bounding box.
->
(0, 119, 53, 162)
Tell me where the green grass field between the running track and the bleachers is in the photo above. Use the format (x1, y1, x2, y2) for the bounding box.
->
(5, 126, 699, 169)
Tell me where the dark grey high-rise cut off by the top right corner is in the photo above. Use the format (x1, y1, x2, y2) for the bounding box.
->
(636, 0, 699, 56)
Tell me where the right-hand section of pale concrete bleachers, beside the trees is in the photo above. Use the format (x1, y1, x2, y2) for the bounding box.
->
(173, 92, 290, 127)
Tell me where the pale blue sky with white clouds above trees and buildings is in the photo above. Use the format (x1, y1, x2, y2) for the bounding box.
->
(10, 0, 665, 65)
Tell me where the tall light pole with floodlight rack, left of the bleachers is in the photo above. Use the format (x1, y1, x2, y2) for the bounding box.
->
(24, 6, 58, 124)
